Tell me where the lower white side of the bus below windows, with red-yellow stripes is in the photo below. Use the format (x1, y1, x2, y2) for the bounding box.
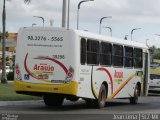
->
(78, 66, 143, 99)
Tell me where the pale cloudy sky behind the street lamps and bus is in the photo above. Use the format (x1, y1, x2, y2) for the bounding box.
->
(0, 0, 160, 48)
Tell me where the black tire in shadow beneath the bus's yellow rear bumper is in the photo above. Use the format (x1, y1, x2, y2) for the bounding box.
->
(43, 94, 64, 107)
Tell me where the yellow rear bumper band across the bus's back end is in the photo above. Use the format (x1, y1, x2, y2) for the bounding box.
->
(14, 80, 78, 95)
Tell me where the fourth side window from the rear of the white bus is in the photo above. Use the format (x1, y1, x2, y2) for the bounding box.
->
(113, 45, 123, 67)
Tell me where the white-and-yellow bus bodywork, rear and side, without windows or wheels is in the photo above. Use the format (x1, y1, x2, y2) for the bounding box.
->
(15, 28, 148, 99)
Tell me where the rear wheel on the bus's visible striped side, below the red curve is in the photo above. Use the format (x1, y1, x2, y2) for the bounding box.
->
(97, 84, 107, 109)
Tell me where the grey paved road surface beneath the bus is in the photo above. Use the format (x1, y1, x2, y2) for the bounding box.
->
(0, 96, 160, 120)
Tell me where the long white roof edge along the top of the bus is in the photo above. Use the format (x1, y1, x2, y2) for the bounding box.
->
(20, 27, 149, 49)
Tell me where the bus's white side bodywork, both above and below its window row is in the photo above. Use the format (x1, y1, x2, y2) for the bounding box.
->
(75, 33, 148, 99)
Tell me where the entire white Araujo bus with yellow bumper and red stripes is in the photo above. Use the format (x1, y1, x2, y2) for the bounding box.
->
(14, 27, 149, 108)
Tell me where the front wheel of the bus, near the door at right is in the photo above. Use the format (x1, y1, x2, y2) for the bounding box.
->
(130, 84, 140, 104)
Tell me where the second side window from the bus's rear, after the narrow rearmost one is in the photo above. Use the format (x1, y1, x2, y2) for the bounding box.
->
(87, 39, 99, 65)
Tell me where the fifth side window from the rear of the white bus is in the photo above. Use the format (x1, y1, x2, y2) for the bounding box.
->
(124, 46, 133, 67)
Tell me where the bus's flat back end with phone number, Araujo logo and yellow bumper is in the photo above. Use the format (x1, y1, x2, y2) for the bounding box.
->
(15, 28, 78, 95)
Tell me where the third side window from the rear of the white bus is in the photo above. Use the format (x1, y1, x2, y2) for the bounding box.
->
(100, 42, 112, 65)
